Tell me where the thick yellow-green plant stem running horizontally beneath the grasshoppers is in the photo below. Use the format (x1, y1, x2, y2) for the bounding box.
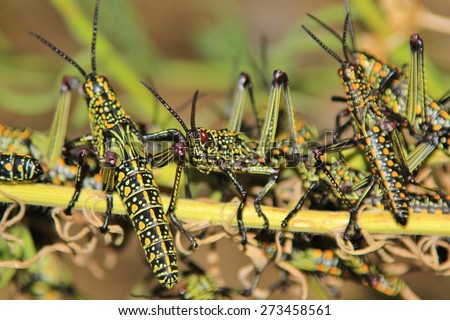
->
(0, 184, 450, 236)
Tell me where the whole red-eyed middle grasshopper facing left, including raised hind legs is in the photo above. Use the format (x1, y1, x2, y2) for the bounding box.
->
(142, 70, 312, 244)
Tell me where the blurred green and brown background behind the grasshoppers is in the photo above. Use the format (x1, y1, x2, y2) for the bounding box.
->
(0, 0, 450, 299)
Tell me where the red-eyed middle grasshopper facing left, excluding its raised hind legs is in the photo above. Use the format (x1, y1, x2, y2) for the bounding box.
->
(141, 81, 279, 245)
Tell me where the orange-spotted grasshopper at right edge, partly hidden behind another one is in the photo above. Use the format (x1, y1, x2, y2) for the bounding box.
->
(309, 15, 450, 161)
